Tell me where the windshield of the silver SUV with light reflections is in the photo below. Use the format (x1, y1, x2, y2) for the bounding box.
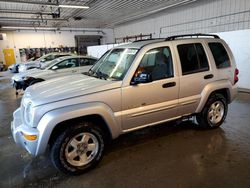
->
(88, 49, 138, 80)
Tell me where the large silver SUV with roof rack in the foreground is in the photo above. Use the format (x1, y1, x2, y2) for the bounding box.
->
(11, 34, 238, 175)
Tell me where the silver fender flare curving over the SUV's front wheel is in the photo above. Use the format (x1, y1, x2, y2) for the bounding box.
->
(36, 102, 122, 155)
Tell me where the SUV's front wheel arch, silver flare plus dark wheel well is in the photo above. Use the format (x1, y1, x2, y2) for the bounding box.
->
(36, 103, 122, 155)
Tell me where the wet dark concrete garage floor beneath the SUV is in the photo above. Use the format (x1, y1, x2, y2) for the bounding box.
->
(0, 72, 250, 188)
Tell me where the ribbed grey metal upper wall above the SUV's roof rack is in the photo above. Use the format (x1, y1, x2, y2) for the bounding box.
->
(114, 0, 250, 37)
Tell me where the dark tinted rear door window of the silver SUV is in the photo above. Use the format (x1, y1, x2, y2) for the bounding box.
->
(177, 43, 209, 75)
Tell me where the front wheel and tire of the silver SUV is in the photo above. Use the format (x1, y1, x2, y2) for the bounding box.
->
(50, 122, 104, 175)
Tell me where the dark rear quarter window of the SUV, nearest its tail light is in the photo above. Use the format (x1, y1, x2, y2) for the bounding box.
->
(208, 43, 230, 69)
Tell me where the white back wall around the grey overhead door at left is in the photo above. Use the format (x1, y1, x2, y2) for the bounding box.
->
(0, 29, 114, 62)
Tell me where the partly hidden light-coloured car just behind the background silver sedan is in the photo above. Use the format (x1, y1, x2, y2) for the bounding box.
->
(18, 52, 75, 72)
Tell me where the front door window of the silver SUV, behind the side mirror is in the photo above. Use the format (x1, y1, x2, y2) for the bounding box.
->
(136, 47, 174, 81)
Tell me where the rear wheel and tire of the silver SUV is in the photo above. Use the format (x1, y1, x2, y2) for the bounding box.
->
(196, 94, 228, 129)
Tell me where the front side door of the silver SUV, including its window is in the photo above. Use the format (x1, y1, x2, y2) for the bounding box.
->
(122, 46, 179, 131)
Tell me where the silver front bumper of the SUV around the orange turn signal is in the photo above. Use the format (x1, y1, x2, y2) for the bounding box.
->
(11, 108, 39, 155)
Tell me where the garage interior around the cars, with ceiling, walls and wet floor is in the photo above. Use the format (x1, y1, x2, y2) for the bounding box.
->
(0, 0, 250, 188)
